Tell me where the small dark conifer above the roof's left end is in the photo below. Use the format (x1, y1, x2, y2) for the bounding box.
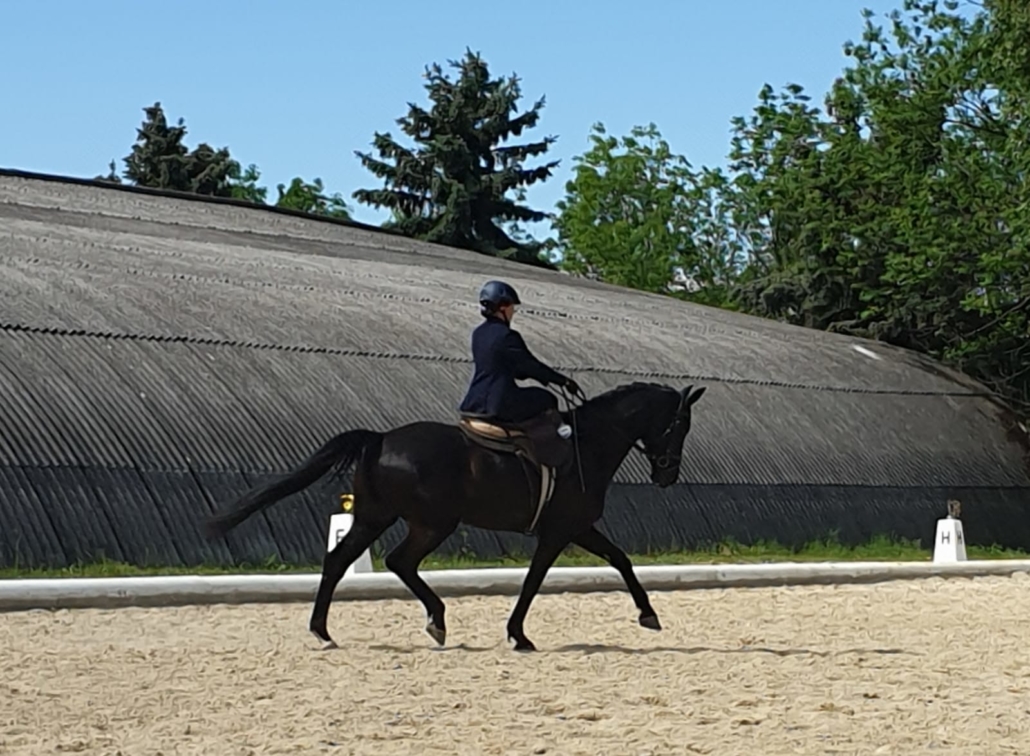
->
(124, 102, 239, 197)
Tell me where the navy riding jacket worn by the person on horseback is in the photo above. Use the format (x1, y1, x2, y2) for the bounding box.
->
(459, 317, 565, 418)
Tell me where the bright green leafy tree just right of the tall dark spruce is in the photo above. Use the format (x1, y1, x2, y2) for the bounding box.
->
(553, 124, 736, 304)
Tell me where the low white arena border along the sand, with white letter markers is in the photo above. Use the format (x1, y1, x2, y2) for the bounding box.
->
(0, 506, 1030, 612)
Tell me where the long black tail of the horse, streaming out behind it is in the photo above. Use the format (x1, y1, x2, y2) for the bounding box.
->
(204, 429, 382, 540)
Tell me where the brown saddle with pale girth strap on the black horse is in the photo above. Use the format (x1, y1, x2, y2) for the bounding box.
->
(458, 410, 573, 536)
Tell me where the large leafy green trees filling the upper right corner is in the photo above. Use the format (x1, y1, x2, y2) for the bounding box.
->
(720, 0, 1030, 418)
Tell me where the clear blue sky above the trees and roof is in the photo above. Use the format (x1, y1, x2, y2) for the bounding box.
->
(0, 0, 902, 236)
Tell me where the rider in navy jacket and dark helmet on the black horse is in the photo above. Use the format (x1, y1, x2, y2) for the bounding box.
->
(460, 281, 580, 439)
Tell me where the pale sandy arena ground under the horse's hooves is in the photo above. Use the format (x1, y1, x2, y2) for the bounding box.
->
(0, 575, 1030, 756)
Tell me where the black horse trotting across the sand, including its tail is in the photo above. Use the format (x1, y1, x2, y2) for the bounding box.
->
(206, 383, 705, 651)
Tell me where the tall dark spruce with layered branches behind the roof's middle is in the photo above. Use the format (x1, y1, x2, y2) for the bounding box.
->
(353, 50, 558, 265)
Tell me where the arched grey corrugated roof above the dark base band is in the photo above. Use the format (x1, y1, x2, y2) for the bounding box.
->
(0, 166, 1030, 568)
